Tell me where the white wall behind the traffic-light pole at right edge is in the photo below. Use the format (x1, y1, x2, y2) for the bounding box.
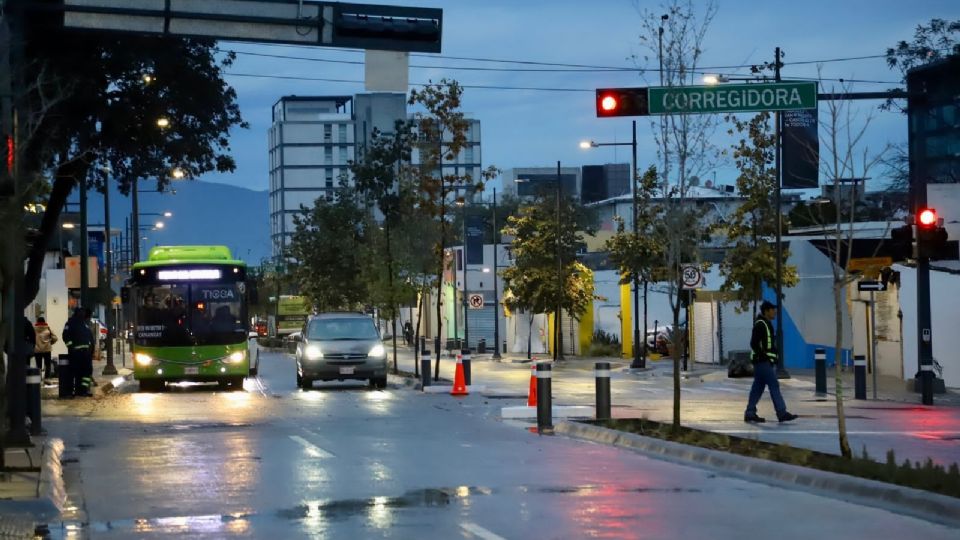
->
(894, 265, 960, 388)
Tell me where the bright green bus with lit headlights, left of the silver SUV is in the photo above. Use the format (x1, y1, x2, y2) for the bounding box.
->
(123, 246, 256, 391)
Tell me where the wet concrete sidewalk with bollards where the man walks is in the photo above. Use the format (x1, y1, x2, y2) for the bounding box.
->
(382, 348, 960, 465)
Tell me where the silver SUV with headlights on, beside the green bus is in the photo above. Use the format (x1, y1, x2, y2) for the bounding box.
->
(296, 313, 387, 389)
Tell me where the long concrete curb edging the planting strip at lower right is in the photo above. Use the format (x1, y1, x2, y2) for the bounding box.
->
(554, 422, 960, 528)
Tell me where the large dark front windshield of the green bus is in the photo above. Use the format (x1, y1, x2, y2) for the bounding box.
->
(135, 283, 247, 347)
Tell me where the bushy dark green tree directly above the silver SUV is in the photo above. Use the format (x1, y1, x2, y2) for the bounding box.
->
(287, 191, 368, 311)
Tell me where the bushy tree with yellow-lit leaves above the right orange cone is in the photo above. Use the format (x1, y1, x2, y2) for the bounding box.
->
(501, 194, 595, 358)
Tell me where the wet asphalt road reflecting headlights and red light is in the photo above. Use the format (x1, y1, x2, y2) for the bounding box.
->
(39, 346, 956, 540)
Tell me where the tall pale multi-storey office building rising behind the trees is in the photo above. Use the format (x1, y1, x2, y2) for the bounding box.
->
(269, 93, 481, 257)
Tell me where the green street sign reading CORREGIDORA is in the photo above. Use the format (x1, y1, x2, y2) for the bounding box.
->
(648, 81, 817, 115)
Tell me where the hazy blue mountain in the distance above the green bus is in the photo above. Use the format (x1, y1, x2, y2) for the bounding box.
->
(83, 180, 271, 266)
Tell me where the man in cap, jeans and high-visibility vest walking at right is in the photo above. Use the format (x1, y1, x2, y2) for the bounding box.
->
(743, 302, 797, 423)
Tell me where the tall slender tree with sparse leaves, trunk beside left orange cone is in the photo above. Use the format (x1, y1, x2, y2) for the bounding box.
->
(408, 79, 498, 378)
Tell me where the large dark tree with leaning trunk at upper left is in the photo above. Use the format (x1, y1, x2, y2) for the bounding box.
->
(14, 27, 246, 301)
